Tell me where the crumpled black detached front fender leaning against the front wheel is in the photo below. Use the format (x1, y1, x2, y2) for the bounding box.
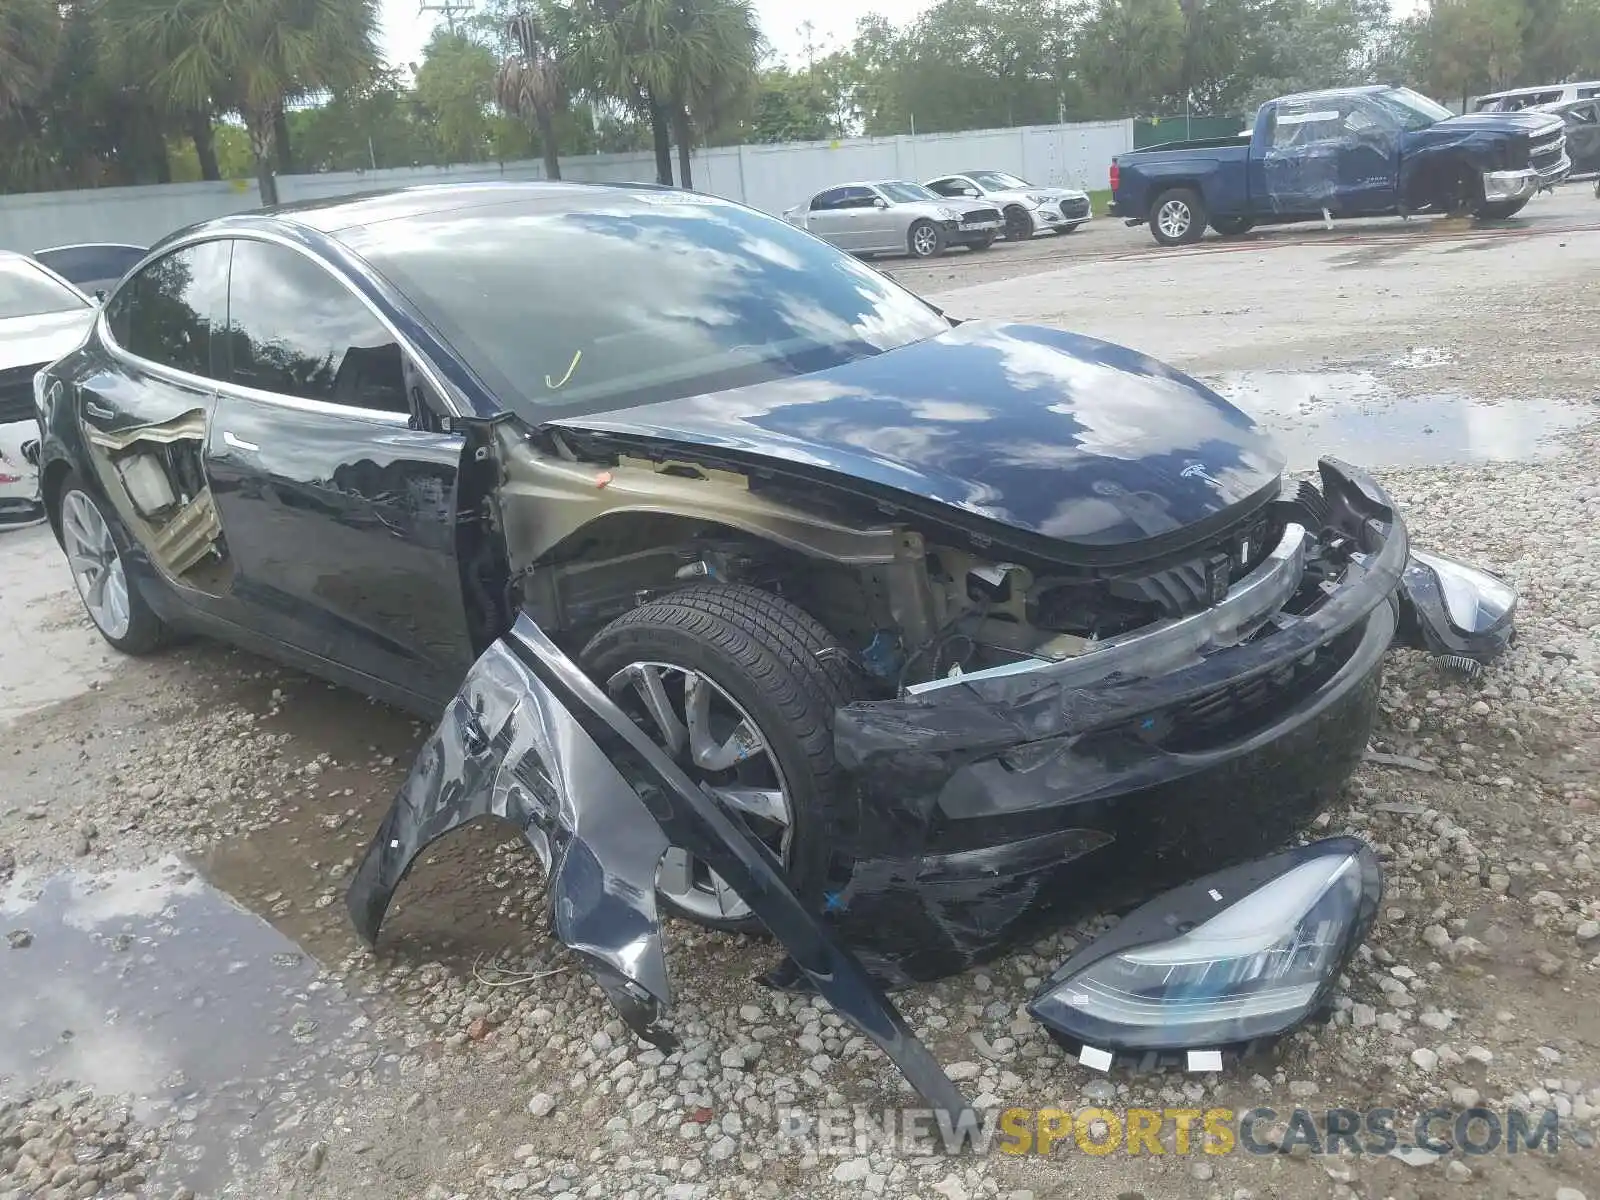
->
(346, 616, 965, 1114)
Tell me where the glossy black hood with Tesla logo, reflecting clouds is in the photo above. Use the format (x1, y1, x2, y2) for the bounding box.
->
(552, 322, 1283, 560)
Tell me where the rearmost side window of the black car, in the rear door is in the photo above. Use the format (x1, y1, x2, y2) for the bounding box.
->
(106, 240, 232, 376)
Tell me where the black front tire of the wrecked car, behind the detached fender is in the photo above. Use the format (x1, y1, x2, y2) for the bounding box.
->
(581, 584, 856, 933)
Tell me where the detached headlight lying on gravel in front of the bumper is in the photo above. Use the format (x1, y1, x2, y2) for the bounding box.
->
(1029, 837, 1382, 1053)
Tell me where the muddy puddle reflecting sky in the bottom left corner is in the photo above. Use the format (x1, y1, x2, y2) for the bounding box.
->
(0, 858, 392, 1195)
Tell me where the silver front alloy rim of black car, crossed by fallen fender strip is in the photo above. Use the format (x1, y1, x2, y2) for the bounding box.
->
(606, 661, 794, 922)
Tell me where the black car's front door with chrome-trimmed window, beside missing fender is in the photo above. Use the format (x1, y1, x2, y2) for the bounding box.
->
(206, 238, 474, 704)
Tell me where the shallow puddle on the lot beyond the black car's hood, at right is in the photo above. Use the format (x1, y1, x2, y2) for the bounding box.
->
(1208, 371, 1600, 470)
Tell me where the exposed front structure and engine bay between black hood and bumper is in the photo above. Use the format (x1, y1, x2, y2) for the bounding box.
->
(498, 434, 1354, 698)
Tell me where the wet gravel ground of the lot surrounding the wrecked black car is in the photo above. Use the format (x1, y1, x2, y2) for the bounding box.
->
(0, 195, 1600, 1200)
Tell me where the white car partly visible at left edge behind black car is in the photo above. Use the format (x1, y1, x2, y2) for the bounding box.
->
(0, 251, 98, 528)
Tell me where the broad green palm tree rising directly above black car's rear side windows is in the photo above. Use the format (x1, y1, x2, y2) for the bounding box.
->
(104, 0, 378, 205)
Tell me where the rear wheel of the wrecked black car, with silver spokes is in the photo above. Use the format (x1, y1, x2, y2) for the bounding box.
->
(56, 472, 173, 656)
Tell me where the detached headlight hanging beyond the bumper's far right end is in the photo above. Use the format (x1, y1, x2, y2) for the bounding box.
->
(1400, 549, 1517, 662)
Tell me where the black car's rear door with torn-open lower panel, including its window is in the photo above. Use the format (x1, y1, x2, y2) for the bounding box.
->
(75, 242, 237, 619)
